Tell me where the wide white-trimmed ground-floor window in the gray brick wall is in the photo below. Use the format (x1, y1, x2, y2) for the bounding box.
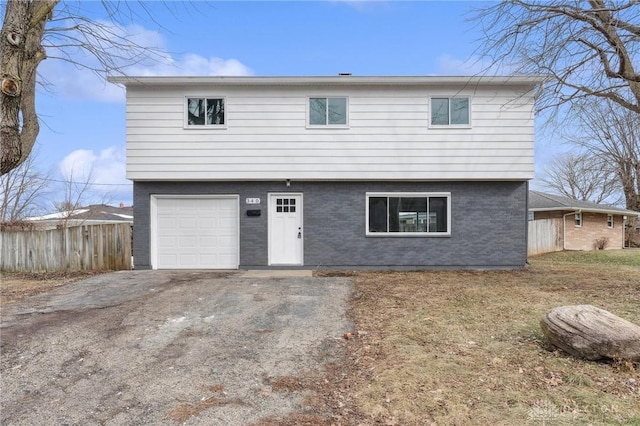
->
(366, 192, 451, 237)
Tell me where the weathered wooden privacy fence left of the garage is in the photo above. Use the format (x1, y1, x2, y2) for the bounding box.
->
(0, 223, 131, 272)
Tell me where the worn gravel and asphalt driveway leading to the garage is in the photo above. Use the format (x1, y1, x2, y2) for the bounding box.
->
(0, 271, 352, 425)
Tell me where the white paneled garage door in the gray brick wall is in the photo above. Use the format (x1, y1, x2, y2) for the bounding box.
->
(152, 196, 238, 269)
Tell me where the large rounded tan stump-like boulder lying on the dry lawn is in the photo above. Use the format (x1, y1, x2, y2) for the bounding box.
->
(540, 305, 640, 361)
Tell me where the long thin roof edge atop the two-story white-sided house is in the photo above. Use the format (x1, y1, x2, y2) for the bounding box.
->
(107, 75, 546, 86)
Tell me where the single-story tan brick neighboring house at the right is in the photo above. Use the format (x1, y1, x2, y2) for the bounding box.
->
(529, 191, 640, 254)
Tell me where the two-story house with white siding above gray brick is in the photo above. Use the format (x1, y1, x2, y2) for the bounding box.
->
(110, 74, 541, 269)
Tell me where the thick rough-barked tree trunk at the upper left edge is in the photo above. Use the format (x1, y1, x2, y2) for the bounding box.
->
(0, 0, 59, 175)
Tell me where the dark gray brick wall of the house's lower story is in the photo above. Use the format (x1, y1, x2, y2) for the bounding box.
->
(134, 182, 527, 269)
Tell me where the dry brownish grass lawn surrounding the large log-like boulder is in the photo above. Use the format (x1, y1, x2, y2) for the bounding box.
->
(324, 250, 640, 425)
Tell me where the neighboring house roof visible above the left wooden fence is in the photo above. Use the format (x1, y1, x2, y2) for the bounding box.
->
(25, 204, 133, 229)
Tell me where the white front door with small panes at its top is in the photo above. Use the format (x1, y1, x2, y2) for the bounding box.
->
(269, 193, 304, 265)
